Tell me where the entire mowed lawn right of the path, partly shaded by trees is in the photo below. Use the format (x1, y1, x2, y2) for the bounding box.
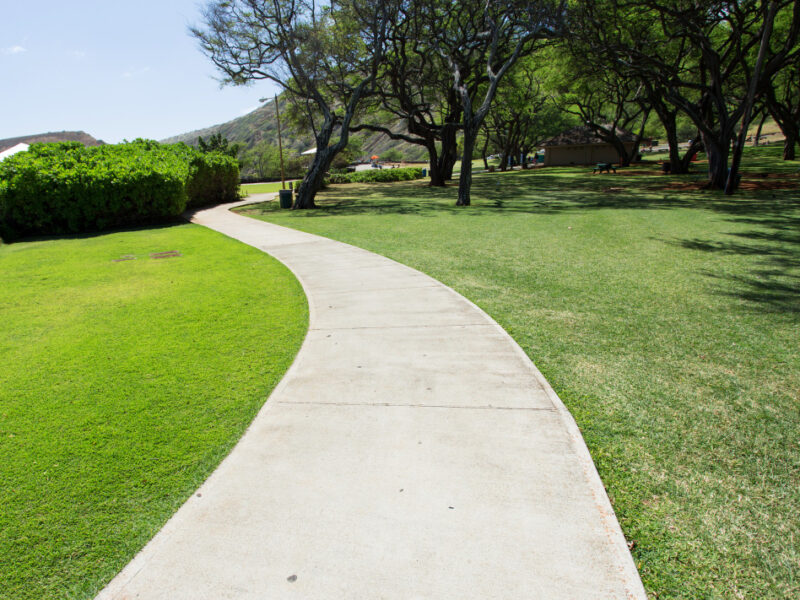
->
(243, 146, 800, 599)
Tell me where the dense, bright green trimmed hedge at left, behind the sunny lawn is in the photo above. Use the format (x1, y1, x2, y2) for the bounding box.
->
(0, 140, 239, 241)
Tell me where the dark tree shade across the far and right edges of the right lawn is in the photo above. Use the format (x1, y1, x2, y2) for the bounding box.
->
(251, 168, 800, 313)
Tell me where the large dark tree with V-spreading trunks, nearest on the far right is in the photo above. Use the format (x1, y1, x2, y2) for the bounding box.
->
(606, 0, 800, 193)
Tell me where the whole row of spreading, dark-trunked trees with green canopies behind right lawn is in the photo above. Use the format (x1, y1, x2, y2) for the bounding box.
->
(192, 0, 800, 208)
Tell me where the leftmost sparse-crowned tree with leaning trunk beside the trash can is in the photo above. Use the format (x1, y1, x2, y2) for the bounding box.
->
(191, 0, 393, 209)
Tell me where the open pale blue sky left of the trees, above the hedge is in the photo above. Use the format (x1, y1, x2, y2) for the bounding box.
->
(0, 0, 276, 143)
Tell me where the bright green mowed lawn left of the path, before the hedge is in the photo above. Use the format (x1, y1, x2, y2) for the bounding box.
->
(0, 225, 307, 600)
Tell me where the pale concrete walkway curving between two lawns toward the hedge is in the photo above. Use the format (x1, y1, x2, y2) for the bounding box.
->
(98, 198, 646, 600)
